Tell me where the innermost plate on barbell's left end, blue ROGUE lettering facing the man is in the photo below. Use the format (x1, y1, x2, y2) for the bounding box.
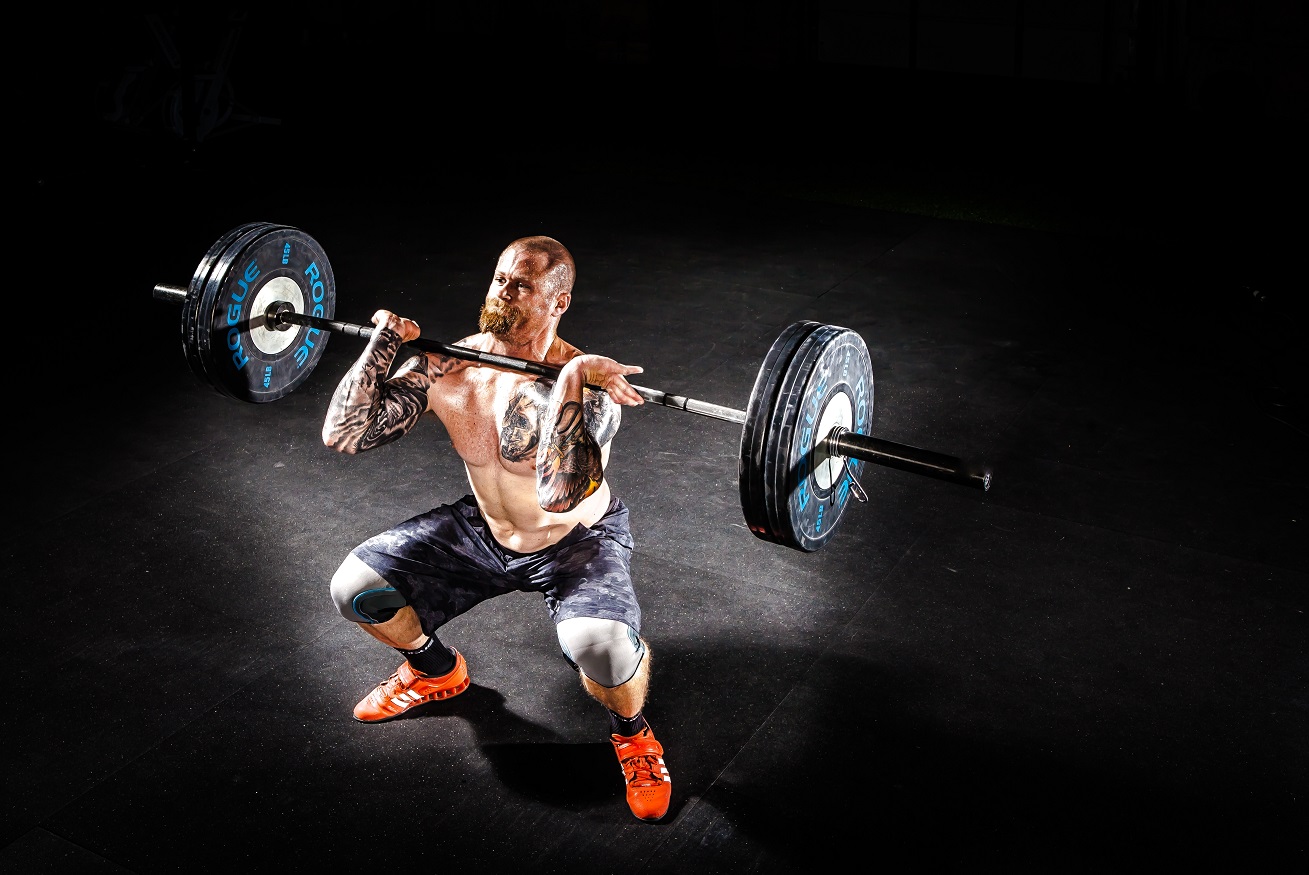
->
(194, 224, 336, 403)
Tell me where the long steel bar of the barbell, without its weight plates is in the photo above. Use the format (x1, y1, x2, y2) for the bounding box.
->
(154, 283, 991, 491)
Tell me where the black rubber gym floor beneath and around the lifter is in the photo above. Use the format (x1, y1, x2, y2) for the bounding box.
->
(0, 20, 1309, 875)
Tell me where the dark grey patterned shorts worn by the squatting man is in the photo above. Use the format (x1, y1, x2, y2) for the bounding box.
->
(351, 495, 641, 635)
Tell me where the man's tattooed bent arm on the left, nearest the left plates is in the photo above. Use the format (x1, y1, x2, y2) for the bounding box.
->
(322, 310, 440, 455)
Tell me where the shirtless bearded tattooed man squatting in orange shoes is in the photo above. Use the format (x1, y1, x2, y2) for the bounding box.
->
(322, 237, 672, 820)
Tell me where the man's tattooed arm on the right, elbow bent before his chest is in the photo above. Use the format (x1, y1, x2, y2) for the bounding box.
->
(537, 355, 644, 513)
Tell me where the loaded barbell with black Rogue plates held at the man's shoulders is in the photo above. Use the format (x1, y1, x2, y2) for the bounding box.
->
(154, 221, 991, 553)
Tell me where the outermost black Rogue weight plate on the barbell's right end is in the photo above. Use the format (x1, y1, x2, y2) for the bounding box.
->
(764, 326, 873, 553)
